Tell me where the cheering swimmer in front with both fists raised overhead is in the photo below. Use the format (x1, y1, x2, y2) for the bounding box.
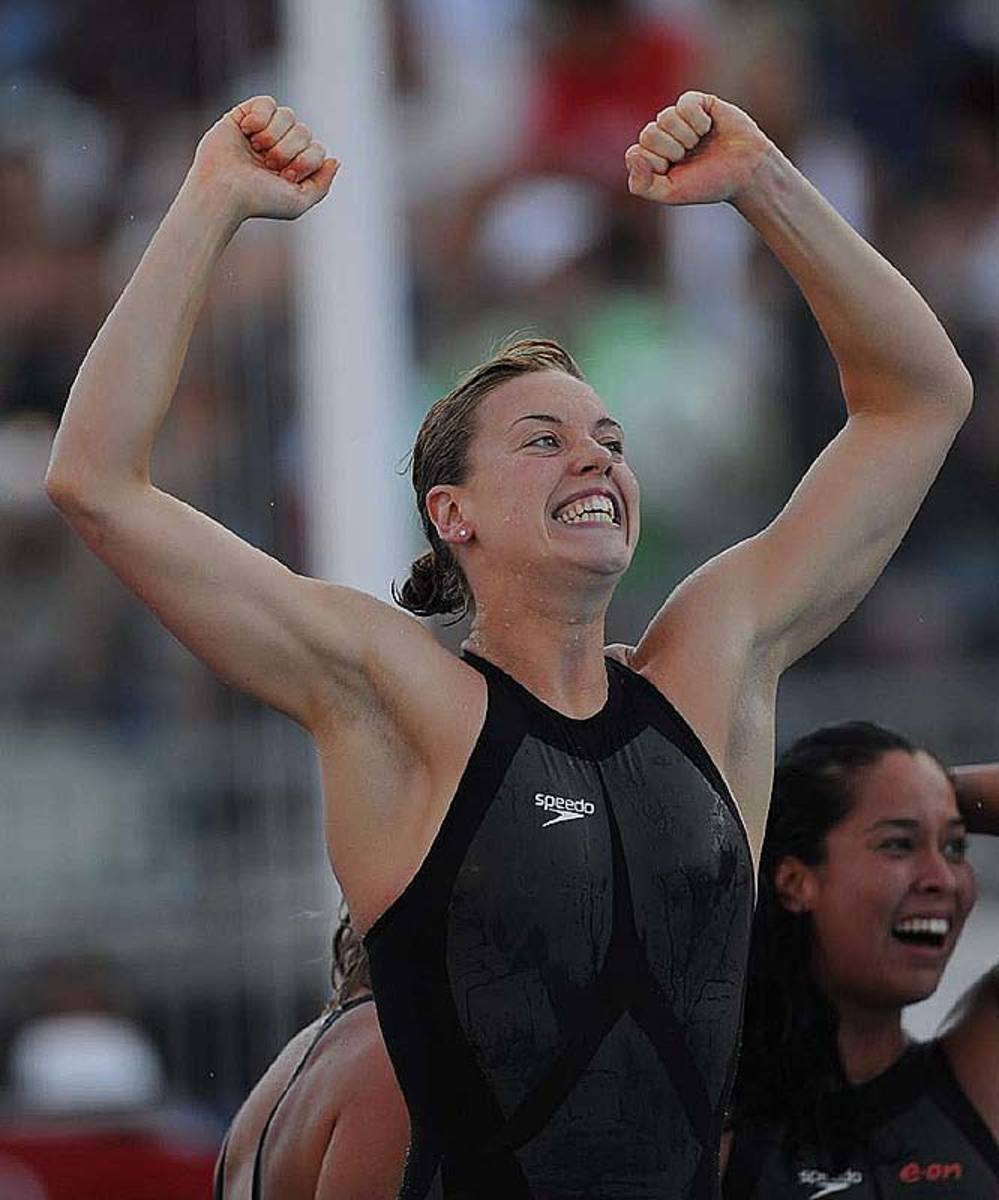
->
(48, 92, 971, 1200)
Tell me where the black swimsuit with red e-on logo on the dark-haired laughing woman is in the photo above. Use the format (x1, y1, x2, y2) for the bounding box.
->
(725, 1042, 999, 1200)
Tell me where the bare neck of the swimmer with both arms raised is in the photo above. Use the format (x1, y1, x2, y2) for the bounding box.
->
(462, 596, 608, 718)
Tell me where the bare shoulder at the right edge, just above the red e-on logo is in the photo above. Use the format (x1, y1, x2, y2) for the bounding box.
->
(940, 966, 999, 1138)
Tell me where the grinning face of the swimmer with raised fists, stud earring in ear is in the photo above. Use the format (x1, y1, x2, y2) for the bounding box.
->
(427, 371, 639, 604)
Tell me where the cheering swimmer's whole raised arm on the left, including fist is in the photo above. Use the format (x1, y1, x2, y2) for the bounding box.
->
(47, 96, 432, 725)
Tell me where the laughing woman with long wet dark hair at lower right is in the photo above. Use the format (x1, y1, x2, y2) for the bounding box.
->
(725, 722, 999, 1200)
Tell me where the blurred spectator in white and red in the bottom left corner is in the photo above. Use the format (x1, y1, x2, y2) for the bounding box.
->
(0, 959, 215, 1200)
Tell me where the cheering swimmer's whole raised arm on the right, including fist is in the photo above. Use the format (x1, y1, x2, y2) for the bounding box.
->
(627, 92, 971, 825)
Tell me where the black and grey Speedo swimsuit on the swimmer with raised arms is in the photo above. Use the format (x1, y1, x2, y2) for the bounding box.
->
(366, 654, 753, 1200)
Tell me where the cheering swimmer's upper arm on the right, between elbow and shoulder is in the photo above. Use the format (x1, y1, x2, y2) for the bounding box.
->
(732, 413, 956, 670)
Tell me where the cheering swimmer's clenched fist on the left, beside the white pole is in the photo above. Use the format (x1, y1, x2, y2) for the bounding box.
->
(189, 96, 340, 221)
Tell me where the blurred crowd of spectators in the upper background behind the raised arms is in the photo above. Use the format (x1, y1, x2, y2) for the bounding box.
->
(0, 0, 999, 1166)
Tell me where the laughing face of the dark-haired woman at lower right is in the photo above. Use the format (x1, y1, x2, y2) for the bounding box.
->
(784, 750, 975, 1009)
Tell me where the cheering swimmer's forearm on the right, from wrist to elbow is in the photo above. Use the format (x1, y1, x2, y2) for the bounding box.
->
(734, 146, 971, 421)
